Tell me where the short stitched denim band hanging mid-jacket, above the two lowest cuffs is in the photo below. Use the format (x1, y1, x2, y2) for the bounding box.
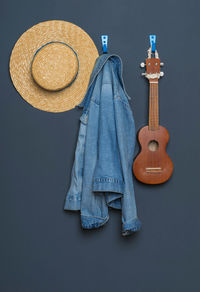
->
(92, 177, 124, 194)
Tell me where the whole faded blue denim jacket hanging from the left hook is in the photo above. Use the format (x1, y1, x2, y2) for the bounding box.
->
(64, 54, 141, 235)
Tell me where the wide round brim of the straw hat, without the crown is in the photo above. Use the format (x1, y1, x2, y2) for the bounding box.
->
(10, 20, 99, 112)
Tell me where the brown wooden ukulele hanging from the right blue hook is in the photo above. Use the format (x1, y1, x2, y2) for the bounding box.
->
(133, 40, 173, 184)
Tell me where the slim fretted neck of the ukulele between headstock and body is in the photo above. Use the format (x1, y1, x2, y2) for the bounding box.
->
(149, 79, 159, 131)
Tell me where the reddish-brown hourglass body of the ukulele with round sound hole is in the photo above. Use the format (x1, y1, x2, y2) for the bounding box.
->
(133, 126, 173, 184)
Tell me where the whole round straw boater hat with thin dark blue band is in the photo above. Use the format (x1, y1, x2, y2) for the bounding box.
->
(10, 20, 98, 112)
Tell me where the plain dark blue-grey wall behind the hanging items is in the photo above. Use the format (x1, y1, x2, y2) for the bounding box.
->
(0, 0, 200, 292)
